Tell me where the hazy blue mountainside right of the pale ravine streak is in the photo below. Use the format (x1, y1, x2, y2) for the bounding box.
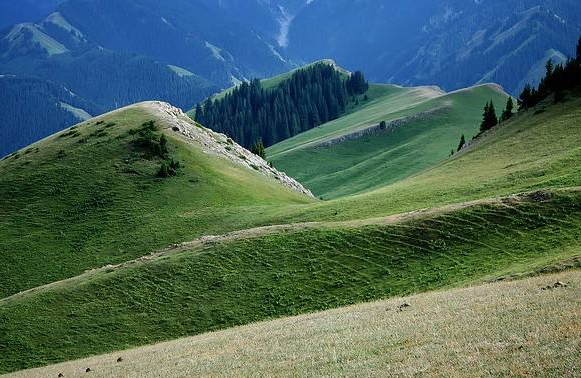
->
(287, 0, 581, 94)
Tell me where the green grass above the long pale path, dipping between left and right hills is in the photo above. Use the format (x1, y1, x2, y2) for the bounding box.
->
(0, 88, 581, 297)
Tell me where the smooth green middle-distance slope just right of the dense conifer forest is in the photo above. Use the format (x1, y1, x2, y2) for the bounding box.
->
(267, 84, 507, 199)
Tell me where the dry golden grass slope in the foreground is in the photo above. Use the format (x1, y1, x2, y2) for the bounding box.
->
(6, 271, 581, 378)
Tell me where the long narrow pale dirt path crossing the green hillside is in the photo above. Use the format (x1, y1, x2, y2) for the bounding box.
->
(0, 187, 581, 307)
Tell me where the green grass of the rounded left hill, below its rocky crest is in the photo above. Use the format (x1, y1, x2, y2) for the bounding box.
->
(0, 103, 310, 297)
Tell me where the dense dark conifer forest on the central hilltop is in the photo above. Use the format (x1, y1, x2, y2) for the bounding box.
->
(195, 63, 369, 148)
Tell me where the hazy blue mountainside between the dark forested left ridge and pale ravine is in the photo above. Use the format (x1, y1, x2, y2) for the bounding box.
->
(53, 0, 289, 86)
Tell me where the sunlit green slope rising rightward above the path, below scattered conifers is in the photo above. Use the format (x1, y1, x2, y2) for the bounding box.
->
(268, 93, 581, 221)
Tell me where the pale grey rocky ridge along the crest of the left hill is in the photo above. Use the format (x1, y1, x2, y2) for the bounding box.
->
(139, 101, 313, 197)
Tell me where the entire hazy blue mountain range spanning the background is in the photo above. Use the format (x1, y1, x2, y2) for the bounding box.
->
(0, 0, 581, 157)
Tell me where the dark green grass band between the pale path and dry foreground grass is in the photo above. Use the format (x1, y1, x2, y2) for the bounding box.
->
(0, 192, 581, 372)
